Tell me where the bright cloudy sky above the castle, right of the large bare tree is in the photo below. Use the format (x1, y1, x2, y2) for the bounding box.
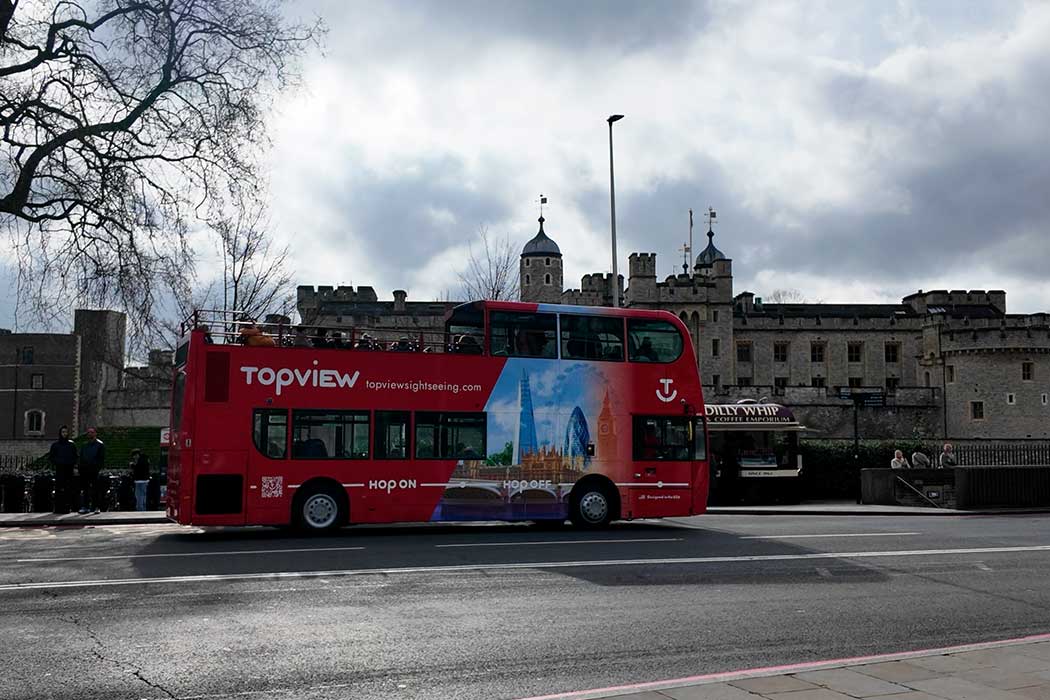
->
(6, 0, 1050, 331)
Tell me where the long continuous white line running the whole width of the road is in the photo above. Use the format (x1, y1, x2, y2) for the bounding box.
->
(6, 545, 1050, 592)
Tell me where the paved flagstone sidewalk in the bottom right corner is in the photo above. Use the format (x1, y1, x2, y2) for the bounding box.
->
(527, 635, 1050, 700)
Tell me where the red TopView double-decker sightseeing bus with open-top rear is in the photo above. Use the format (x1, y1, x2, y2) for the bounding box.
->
(167, 302, 708, 530)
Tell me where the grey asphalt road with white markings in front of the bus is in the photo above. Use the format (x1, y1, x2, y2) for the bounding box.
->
(0, 515, 1050, 700)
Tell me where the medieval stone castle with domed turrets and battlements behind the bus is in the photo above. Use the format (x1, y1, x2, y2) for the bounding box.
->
(298, 217, 1050, 440)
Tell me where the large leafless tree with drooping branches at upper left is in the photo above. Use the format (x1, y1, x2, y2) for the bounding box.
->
(0, 0, 322, 340)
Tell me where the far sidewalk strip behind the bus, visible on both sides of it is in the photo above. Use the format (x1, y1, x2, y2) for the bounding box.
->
(0, 501, 1050, 528)
